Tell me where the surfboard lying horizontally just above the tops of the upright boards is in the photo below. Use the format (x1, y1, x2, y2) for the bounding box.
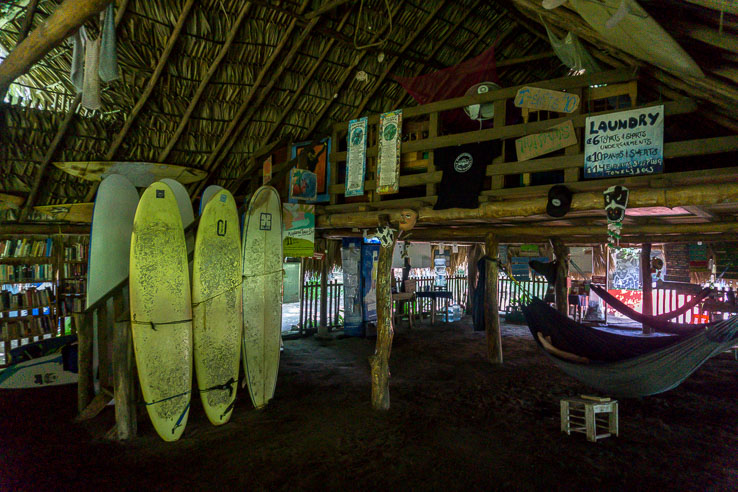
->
(54, 161, 208, 188)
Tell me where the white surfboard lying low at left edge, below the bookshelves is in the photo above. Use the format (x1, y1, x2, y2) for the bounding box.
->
(0, 353, 77, 389)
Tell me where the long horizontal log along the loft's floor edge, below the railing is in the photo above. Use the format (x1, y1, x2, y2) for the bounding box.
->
(316, 183, 738, 234)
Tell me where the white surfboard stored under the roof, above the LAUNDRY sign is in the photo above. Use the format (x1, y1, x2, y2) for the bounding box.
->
(570, 0, 705, 77)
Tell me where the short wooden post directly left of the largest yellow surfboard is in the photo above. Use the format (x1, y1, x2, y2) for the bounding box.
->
(113, 291, 138, 440)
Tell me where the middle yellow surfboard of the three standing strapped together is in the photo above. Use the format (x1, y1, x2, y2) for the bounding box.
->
(192, 189, 243, 425)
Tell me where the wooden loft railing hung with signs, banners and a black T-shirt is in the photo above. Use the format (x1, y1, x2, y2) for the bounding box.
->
(319, 69, 738, 213)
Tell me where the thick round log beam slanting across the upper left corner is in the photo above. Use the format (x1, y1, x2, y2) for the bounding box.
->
(0, 0, 110, 88)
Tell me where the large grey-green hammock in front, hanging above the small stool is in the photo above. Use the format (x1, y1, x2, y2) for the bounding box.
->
(523, 300, 738, 397)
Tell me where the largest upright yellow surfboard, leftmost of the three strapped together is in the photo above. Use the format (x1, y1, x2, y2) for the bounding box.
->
(129, 183, 192, 441)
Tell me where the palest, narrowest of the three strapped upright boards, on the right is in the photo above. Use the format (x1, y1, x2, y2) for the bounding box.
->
(243, 186, 282, 408)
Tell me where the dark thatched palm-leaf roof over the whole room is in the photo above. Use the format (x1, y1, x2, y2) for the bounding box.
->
(0, 0, 738, 215)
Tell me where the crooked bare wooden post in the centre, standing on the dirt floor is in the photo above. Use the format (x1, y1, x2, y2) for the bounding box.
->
(369, 231, 397, 410)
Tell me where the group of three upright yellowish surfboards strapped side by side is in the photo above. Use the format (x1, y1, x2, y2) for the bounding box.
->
(121, 180, 282, 441)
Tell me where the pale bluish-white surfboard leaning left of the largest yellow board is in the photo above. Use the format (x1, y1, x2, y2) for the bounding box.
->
(86, 174, 138, 390)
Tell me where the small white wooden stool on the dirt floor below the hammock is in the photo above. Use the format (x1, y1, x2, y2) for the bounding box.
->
(561, 397, 618, 442)
